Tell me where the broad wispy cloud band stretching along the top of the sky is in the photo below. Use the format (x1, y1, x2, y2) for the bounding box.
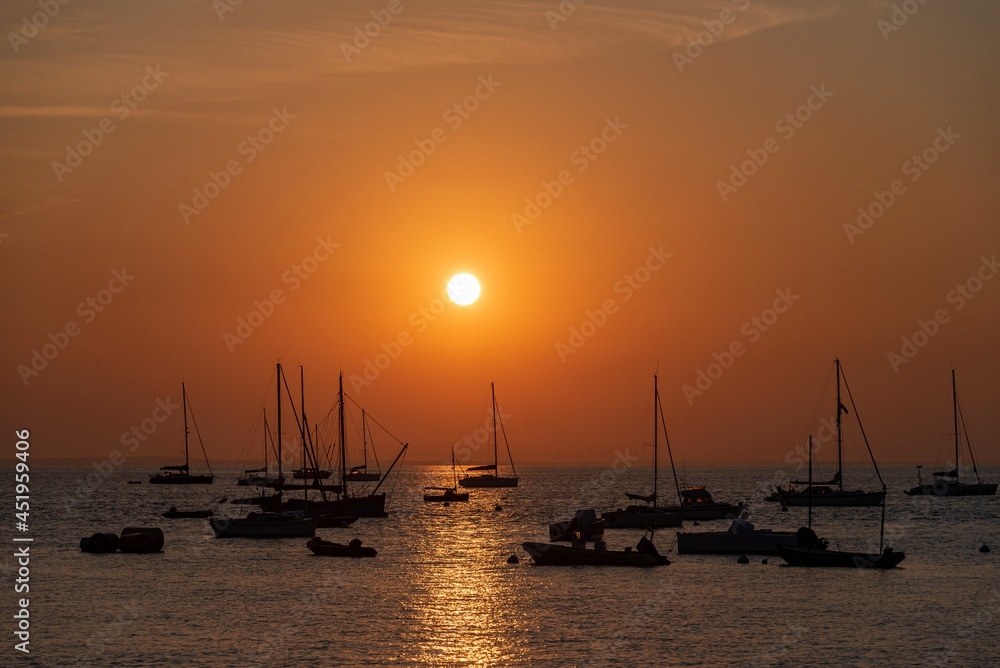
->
(0, 0, 868, 109)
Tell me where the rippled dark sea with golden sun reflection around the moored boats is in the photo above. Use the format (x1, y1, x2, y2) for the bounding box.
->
(15, 466, 1000, 666)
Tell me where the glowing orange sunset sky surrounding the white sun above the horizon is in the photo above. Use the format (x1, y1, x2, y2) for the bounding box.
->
(0, 0, 1000, 464)
